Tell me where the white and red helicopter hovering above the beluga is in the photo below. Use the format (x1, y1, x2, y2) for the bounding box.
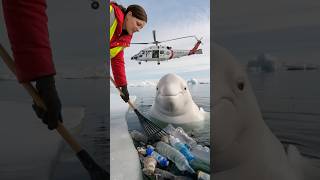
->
(131, 30, 202, 65)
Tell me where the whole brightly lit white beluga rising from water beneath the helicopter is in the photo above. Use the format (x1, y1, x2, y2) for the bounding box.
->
(150, 74, 210, 124)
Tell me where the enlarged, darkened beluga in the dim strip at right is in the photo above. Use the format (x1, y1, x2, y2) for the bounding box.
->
(211, 43, 320, 180)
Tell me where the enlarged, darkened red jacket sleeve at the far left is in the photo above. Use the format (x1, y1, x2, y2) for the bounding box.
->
(2, 0, 55, 82)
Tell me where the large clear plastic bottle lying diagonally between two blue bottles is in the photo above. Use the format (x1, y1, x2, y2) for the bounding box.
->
(156, 141, 195, 173)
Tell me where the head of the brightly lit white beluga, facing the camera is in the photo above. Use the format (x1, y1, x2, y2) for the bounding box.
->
(154, 74, 194, 116)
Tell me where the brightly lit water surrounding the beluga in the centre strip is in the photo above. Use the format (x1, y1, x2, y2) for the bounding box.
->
(127, 84, 210, 146)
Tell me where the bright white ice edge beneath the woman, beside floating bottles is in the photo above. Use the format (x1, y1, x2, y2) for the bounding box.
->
(110, 93, 142, 180)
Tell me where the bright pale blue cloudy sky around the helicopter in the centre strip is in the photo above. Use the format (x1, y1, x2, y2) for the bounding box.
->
(116, 0, 210, 82)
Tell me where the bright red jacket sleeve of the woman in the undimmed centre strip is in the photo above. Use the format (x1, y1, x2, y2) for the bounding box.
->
(111, 50, 127, 87)
